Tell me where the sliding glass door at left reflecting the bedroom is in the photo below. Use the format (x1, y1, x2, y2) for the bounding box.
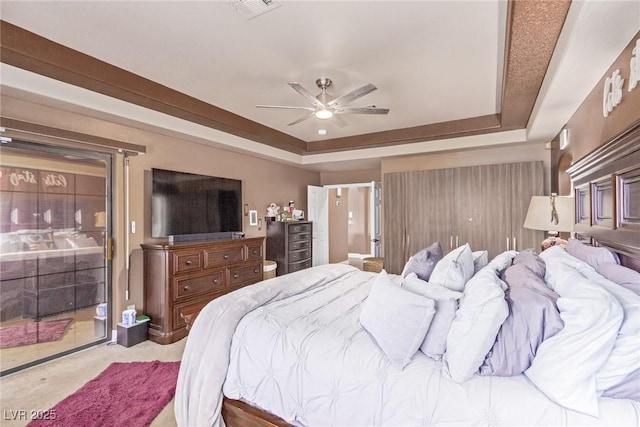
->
(0, 141, 111, 375)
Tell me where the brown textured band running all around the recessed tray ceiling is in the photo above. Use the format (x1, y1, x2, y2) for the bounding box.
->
(0, 0, 570, 155)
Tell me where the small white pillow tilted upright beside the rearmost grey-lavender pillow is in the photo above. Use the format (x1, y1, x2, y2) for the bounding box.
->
(429, 243, 473, 292)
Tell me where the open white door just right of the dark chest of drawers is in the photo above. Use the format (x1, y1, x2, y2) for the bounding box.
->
(307, 185, 329, 266)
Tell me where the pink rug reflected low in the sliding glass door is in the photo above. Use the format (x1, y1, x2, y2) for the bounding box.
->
(0, 318, 73, 348)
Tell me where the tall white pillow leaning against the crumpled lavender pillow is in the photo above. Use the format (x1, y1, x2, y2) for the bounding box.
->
(444, 264, 509, 383)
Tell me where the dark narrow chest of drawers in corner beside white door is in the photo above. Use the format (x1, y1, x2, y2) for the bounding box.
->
(266, 221, 313, 276)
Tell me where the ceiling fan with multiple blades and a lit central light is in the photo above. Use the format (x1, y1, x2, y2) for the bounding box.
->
(256, 77, 389, 127)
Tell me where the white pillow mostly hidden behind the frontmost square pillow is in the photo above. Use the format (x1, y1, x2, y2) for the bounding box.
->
(402, 273, 462, 360)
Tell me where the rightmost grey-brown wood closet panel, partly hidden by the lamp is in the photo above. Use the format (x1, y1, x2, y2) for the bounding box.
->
(509, 161, 545, 250)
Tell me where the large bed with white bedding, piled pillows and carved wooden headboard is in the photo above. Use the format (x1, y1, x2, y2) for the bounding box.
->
(175, 125, 640, 426)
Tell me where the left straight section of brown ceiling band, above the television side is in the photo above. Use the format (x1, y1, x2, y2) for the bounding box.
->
(0, 21, 305, 154)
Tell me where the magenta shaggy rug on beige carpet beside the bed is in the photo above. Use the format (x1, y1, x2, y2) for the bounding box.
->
(28, 360, 180, 427)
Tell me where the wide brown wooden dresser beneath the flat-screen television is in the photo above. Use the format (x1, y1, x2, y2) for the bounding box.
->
(141, 237, 264, 344)
